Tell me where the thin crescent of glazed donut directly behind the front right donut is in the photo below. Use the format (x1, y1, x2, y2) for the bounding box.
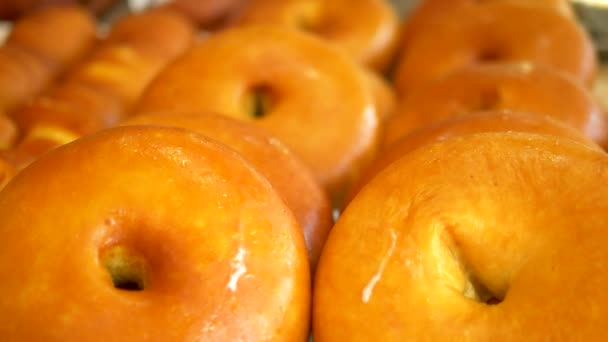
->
(347, 110, 601, 203)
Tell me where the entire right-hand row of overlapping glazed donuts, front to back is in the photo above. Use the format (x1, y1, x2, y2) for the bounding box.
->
(312, 0, 608, 341)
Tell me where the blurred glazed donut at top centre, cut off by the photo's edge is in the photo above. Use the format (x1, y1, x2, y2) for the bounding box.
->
(236, 0, 399, 70)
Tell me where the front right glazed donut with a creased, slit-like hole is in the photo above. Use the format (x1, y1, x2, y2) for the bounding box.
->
(313, 133, 608, 342)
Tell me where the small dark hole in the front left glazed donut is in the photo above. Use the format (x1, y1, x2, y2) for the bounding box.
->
(101, 245, 149, 291)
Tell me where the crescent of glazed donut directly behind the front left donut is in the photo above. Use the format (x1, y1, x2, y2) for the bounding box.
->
(123, 113, 333, 271)
